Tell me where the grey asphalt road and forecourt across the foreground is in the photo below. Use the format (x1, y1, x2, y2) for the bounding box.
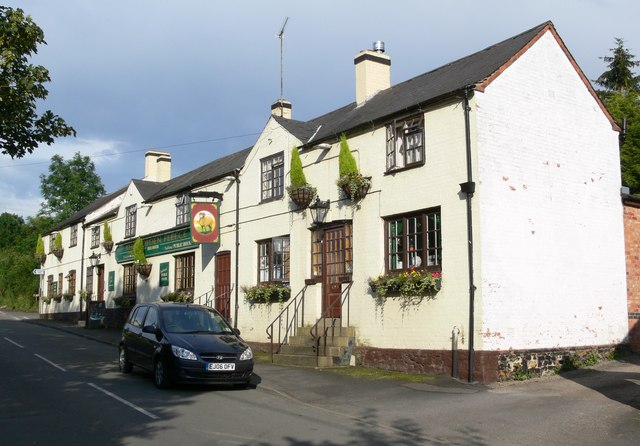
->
(0, 311, 640, 446)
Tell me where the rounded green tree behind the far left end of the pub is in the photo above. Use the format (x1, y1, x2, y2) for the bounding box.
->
(38, 152, 105, 222)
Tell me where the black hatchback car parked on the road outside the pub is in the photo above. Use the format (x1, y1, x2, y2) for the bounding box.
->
(118, 302, 253, 388)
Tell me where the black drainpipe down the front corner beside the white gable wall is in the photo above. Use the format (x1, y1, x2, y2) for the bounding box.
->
(460, 86, 476, 382)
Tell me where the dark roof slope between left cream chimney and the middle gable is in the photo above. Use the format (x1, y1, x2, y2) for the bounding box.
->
(144, 147, 251, 202)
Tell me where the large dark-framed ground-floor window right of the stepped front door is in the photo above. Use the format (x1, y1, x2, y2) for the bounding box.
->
(385, 208, 442, 272)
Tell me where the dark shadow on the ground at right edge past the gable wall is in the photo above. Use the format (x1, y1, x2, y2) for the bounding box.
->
(560, 355, 640, 410)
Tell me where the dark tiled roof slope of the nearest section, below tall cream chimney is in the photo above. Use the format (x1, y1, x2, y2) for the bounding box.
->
(300, 22, 553, 143)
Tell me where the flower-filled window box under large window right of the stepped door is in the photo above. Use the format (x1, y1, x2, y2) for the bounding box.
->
(369, 270, 442, 298)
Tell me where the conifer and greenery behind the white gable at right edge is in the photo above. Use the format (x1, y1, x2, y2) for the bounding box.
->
(595, 38, 640, 193)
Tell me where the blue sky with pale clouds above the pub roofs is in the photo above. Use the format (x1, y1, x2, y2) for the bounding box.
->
(0, 0, 640, 217)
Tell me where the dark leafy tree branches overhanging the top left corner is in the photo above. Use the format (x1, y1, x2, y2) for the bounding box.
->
(0, 6, 76, 158)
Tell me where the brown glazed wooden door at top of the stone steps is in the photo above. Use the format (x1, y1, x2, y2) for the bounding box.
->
(322, 224, 353, 318)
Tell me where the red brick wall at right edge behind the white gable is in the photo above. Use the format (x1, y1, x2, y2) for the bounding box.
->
(624, 202, 640, 351)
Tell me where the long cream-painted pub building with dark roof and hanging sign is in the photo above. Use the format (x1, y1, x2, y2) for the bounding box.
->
(40, 22, 628, 382)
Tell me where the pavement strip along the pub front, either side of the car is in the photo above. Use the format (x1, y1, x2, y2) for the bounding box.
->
(28, 319, 489, 405)
